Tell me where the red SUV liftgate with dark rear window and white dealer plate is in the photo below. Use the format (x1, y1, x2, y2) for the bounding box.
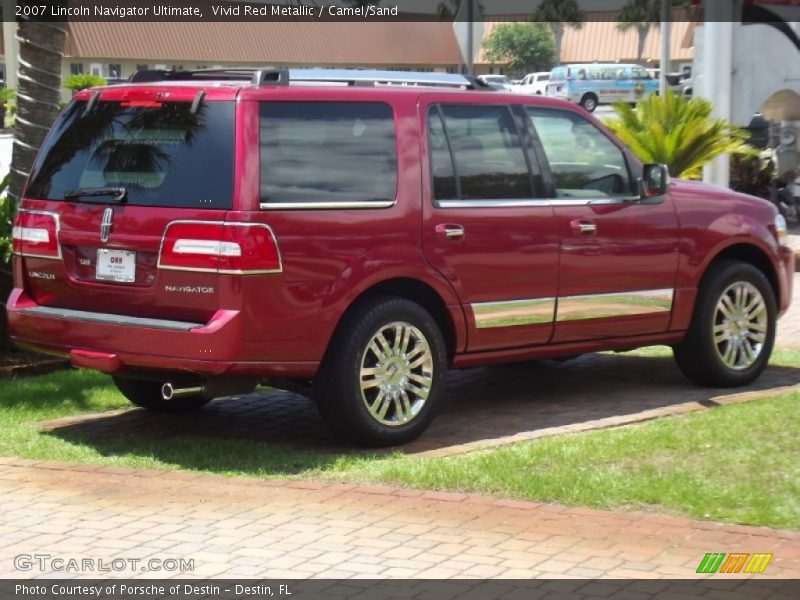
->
(22, 88, 234, 322)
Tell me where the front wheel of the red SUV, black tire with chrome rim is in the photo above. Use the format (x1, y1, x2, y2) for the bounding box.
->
(673, 260, 777, 387)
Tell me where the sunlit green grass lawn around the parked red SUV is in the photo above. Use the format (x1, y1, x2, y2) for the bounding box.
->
(0, 348, 800, 529)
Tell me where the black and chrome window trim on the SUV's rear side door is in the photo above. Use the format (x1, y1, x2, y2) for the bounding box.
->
(423, 101, 550, 209)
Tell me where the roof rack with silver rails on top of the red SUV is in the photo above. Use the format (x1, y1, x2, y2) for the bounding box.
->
(130, 67, 492, 90)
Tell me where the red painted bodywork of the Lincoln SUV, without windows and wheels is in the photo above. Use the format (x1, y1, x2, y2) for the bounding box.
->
(7, 83, 793, 377)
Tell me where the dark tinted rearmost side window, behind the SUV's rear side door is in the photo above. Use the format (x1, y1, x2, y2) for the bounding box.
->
(261, 102, 397, 203)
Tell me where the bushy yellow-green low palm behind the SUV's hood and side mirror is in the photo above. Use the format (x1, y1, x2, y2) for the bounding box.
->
(605, 91, 756, 179)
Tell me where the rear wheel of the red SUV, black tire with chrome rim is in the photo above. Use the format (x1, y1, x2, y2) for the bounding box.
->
(314, 296, 447, 446)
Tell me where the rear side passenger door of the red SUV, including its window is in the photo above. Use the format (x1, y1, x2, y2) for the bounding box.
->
(420, 101, 558, 351)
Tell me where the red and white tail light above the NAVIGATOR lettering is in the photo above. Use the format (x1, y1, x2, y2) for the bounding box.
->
(158, 221, 283, 275)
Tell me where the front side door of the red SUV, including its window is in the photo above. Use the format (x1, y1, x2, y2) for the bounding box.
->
(526, 107, 679, 343)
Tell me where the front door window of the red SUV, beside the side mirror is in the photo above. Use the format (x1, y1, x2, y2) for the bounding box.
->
(528, 108, 632, 198)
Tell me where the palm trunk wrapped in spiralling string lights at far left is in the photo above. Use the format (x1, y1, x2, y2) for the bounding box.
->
(8, 20, 67, 200)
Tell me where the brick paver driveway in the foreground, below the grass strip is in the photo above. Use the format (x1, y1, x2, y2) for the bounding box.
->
(0, 459, 800, 578)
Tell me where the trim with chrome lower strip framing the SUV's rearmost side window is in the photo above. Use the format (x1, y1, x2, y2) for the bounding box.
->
(256, 99, 400, 211)
